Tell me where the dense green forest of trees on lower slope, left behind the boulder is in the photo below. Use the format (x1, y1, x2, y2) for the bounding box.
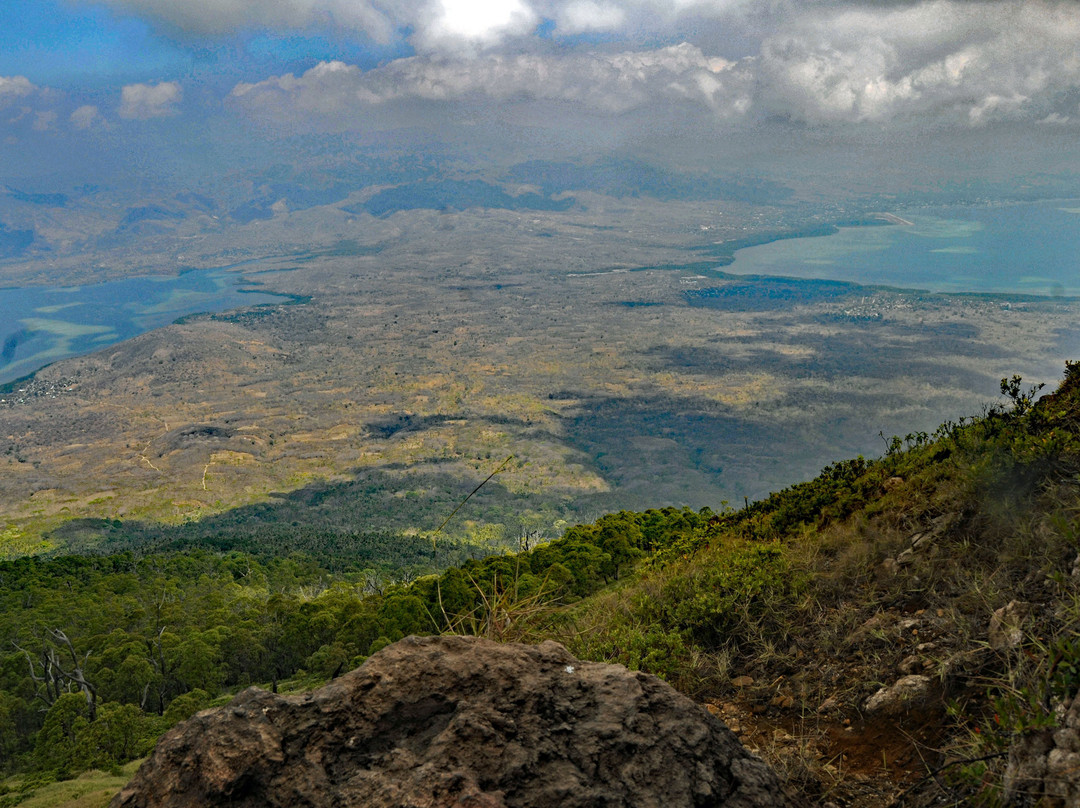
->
(0, 509, 710, 777)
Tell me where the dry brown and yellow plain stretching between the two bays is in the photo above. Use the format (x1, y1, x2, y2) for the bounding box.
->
(0, 189, 1080, 555)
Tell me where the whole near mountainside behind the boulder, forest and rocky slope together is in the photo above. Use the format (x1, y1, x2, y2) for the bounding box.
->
(6, 363, 1080, 806)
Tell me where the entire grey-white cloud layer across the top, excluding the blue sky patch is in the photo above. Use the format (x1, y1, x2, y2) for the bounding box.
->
(10, 0, 1080, 147)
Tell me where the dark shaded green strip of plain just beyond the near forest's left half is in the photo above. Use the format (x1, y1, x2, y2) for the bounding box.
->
(50, 463, 605, 570)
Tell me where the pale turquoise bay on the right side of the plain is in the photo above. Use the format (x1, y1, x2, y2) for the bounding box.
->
(729, 200, 1080, 296)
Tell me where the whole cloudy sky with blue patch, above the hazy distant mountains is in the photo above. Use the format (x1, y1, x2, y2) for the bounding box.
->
(0, 0, 1080, 194)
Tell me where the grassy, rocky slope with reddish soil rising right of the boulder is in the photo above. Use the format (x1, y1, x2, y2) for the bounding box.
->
(540, 365, 1080, 805)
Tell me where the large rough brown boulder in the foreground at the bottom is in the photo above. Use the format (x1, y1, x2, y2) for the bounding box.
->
(112, 637, 793, 808)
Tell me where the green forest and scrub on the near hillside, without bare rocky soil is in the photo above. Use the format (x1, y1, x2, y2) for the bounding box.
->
(0, 363, 1080, 805)
